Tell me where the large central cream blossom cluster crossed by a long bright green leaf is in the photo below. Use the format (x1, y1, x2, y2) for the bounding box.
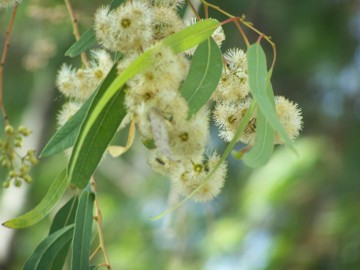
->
(95, 0, 226, 201)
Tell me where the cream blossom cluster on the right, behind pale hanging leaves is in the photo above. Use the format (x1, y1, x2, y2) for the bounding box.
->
(212, 48, 302, 145)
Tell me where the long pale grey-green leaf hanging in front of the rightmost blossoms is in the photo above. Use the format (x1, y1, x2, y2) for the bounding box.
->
(246, 43, 296, 152)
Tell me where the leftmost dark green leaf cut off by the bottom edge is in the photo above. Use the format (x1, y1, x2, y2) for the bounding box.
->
(23, 225, 74, 270)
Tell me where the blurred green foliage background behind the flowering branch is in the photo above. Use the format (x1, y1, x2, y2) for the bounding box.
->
(0, 0, 360, 270)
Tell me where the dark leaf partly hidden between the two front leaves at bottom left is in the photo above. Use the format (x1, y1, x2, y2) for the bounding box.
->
(49, 196, 78, 270)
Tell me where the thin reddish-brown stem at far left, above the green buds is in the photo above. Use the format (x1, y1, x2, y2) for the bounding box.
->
(0, 4, 18, 125)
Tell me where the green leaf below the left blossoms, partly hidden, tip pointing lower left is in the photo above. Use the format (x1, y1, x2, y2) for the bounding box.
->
(40, 65, 117, 157)
